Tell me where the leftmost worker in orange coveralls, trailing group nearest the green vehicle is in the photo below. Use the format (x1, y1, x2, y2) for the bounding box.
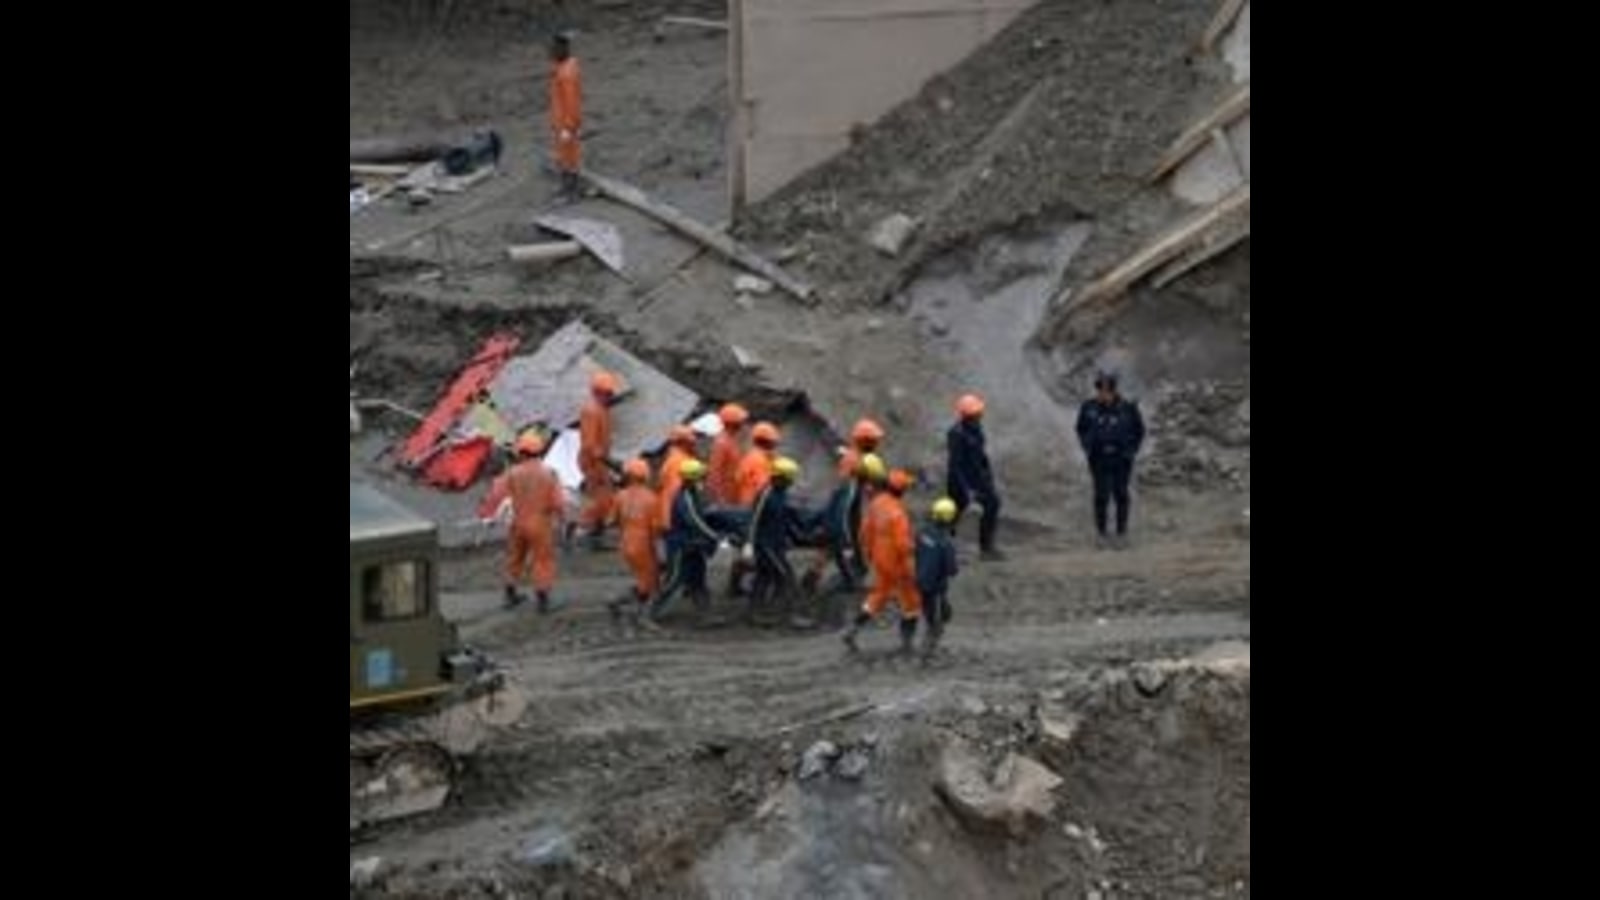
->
(504, 431, 565, 613)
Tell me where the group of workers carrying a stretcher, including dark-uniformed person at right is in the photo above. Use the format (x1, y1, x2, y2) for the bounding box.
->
(494, 372, 1144, 653)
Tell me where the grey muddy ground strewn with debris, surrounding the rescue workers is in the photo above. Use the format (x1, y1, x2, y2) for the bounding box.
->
(350, 0, 1250, 898)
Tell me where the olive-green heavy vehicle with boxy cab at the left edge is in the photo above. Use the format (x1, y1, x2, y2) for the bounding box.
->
(350, 480, 523, 831)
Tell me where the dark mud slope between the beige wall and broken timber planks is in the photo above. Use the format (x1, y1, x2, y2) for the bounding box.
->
(741, 0, 1227, 306)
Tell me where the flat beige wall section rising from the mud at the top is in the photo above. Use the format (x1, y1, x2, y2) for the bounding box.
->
(730, 0, 1034, 208)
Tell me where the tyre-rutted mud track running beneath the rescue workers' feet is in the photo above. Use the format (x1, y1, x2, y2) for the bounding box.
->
(368, 531, 1250, 834)
